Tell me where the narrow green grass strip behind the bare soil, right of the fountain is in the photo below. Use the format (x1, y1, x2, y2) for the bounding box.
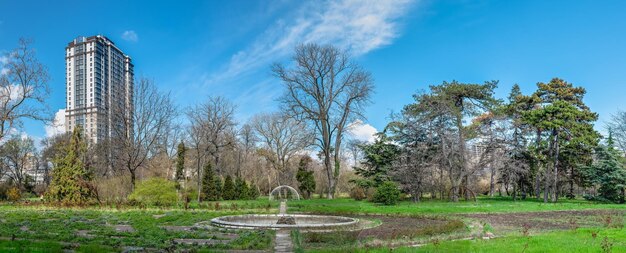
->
(289, 198, 626, 215)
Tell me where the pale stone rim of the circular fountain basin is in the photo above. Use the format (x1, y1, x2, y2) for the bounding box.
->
(211, 214, 359, 229)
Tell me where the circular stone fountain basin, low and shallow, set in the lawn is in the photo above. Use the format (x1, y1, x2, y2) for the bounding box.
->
(211, 214, 359, 229)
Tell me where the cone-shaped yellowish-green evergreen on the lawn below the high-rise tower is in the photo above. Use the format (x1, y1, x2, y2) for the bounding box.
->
(46, 126, 96, 204)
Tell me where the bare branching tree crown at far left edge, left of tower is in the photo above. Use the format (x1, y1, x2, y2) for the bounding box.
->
(0, 39, 51, 141)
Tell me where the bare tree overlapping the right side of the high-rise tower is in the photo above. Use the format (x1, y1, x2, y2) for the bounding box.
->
(112, 78, 176, 188)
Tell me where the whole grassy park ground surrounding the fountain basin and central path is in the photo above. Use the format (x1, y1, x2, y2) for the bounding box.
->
(0, 197, 626, 252)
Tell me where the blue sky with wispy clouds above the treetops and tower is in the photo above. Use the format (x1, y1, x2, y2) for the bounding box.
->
(0, 0, 626, 142)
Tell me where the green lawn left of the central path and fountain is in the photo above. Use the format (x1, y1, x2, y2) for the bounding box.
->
(0, 200, 277, 252)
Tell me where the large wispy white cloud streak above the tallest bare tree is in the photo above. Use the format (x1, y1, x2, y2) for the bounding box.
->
(205, 0, 413, 85)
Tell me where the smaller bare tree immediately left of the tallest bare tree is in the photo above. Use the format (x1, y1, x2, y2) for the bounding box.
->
(252, 113, 313, 184)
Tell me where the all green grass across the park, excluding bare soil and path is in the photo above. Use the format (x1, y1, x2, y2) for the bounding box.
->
(0, 198, 626, 252)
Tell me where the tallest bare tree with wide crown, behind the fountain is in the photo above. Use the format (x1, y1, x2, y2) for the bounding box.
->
(272, 44, 373, 198)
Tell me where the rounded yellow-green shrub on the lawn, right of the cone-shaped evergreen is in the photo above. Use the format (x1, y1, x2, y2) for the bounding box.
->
(128, 177, 178, 206)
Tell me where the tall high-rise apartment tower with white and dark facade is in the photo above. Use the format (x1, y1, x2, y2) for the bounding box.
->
(65, 35, 133, 143)
